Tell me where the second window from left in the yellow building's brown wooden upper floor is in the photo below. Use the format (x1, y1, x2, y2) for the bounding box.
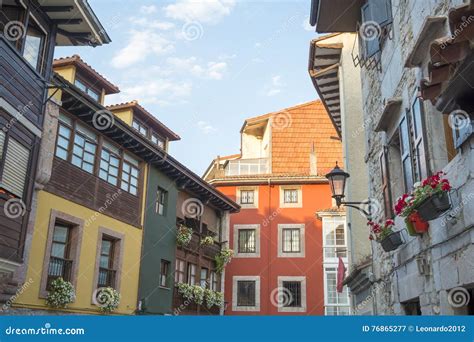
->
(71, 124, 97, 173)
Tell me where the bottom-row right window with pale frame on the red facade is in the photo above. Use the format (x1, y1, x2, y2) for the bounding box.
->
(278, 276, 306, 312)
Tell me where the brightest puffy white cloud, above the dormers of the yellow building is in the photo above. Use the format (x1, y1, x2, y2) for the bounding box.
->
(112, 30, 174, 68)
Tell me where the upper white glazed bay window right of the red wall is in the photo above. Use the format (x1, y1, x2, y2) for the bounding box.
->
(323, 216, 347, 263)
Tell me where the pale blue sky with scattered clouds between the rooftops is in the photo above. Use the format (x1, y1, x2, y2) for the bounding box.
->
(56, 0, 317, 174)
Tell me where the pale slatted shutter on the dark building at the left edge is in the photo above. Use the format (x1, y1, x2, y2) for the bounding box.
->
(2, 137, 30, 197)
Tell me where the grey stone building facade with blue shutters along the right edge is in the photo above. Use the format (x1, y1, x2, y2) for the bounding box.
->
(312, 0, 474, 315)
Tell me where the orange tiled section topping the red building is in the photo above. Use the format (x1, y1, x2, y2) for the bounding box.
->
(272, 100, 342, 175)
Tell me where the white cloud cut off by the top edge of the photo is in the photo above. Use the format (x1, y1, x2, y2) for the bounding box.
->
(163, 0, 235, 24)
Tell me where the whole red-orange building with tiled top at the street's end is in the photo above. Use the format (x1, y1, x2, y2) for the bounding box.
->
(204, 101, 350, 315)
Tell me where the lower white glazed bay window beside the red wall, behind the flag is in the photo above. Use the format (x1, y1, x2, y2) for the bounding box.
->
(324, 267, 350, 316)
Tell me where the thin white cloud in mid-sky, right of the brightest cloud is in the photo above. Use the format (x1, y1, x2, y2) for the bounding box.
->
(166, 57, 227, 80)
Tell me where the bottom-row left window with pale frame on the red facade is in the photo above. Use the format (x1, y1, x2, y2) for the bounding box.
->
(232, 276, 260, 311)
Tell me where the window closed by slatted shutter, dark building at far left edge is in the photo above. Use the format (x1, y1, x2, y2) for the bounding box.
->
(0, 130, 30, 197)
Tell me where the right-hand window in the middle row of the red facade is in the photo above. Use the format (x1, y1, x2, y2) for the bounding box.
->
(278, 223, 305, 258)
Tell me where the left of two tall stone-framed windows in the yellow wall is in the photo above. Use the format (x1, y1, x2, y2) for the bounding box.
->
(46, 223, 72, 289)
